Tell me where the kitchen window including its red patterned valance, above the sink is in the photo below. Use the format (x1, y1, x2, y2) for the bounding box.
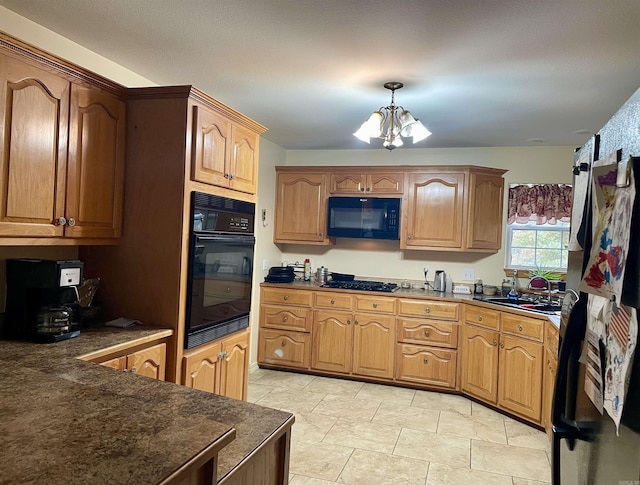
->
(506, 184, 572, 271)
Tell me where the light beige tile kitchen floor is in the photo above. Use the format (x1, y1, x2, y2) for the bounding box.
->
(248, 369, 551, 485)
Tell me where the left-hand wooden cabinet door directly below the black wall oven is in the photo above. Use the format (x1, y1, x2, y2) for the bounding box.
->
(182, 341, 222, 394)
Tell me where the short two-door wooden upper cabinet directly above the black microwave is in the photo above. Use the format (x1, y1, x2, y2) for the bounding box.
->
(329, 169, 404, 195)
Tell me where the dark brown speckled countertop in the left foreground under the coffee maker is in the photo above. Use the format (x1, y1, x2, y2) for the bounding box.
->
(0, 327, 291, 485)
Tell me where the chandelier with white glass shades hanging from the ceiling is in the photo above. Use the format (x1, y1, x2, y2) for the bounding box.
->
(353, 82, 431, 150)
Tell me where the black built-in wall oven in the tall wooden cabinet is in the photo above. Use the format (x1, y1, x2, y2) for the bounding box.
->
(184, 192, 255, 349)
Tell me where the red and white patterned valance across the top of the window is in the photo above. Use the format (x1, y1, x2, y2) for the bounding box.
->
(507, 184, 572, 224)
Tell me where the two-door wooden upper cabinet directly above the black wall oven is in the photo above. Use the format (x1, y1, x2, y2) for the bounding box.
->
(191, 104, 260, 194)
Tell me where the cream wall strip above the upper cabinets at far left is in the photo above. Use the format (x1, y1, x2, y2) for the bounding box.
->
(0, 5, 156, 87)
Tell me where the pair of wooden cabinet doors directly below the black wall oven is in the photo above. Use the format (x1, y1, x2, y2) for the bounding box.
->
(182, 330, 249, 400)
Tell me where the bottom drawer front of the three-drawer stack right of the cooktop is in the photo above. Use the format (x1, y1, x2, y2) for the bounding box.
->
(396, 345, 458, 389)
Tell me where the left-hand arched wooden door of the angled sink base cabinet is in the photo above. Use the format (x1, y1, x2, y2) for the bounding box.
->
(461, 325, 499, 404)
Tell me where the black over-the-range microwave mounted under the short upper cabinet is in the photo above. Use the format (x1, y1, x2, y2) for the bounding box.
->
(327, 197, 401, 240)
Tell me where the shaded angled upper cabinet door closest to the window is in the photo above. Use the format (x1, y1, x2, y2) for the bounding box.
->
(466, 173, 504, 251)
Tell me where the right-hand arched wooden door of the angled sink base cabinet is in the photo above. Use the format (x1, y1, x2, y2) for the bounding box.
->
(498, 335, 542, 423)
